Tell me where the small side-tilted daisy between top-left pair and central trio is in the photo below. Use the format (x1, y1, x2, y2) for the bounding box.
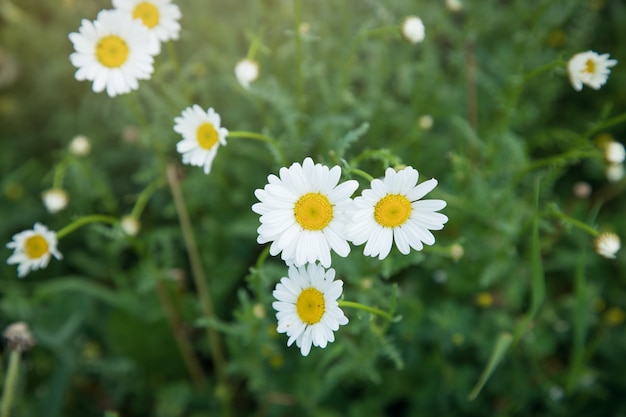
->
(174, 104, 228, 174)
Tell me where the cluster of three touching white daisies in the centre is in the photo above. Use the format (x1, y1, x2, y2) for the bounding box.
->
(252, 158, 448, 356)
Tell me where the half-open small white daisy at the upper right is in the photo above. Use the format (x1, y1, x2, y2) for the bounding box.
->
(567, 51, 617, 91)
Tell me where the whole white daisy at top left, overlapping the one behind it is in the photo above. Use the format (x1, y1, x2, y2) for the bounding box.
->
(69, 10, 158, 97)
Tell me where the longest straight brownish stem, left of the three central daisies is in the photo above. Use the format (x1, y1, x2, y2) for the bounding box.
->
(167, 164, 232, 415)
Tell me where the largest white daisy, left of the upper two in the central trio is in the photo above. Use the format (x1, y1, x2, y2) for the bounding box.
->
(252, 158, 358, 267)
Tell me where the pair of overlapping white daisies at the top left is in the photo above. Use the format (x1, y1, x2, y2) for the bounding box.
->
(69, 0, 181, 97)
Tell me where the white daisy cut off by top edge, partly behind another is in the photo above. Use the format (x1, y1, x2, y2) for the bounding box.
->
(113, 0, 182, 53)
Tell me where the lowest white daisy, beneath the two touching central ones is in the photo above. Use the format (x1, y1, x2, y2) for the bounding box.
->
(272, 264, 348, 356)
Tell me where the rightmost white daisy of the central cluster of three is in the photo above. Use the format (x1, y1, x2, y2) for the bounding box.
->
(348, 167, 448, 259)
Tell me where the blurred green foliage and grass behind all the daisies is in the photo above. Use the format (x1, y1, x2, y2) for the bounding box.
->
(0, 0, 626, 417)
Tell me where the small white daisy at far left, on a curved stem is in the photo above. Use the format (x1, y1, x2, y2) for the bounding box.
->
(7, 223, 63, 278)
